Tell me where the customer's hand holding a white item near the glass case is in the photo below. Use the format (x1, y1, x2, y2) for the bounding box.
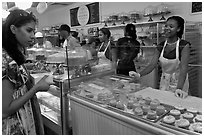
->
(34, 75, 54, 92)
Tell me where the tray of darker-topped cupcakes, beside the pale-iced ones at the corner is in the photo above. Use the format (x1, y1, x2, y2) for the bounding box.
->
(105, 94, 172, 123)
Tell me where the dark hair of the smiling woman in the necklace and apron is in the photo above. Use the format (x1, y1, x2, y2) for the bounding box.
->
(167, 16, 185, 38)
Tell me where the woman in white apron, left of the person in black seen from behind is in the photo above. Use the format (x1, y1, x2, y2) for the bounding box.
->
(97, 28, 114, 64)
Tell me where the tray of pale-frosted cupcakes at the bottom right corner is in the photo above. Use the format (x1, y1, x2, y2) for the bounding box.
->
(160, 106, 202, 134)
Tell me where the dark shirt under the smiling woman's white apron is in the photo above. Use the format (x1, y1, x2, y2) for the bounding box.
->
(157, 40, 191, 60)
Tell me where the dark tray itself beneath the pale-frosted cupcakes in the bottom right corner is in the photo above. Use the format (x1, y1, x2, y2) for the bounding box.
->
(159, 110, 201, 135)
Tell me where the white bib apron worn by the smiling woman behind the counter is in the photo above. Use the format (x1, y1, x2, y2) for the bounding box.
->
(159, 39, 189, 93)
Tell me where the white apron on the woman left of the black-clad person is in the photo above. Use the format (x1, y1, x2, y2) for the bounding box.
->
(98, 41, 111, 64)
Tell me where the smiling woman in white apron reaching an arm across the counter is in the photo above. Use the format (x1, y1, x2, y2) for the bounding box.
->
(130, 16, 190, 98)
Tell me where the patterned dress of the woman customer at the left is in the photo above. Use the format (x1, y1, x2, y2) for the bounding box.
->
(2, 51, 36, 135)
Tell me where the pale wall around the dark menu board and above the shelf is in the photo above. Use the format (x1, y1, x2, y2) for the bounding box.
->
(34, 2, 202, 30)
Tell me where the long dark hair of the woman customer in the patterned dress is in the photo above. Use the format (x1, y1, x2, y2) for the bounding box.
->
(2, 9, 37, 65)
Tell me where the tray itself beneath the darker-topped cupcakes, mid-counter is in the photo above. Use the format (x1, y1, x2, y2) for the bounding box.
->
(107, 103, 172, 123)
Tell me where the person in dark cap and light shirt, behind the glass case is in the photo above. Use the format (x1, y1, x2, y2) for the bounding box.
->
(59, 24, 81, 50)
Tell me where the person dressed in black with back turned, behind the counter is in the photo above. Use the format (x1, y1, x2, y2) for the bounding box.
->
(113, 24, 140, 75)
